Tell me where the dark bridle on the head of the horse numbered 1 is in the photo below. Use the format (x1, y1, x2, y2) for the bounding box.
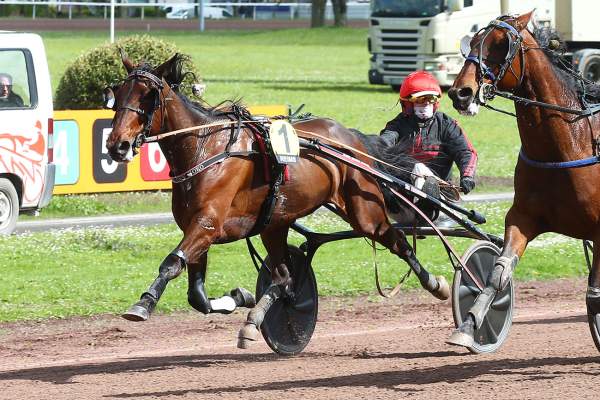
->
(115, 70, 164, 152)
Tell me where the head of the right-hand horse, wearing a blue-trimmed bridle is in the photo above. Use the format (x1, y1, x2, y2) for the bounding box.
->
(448, 11, 533, 115)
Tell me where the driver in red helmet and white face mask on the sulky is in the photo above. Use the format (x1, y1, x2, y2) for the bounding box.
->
(381, 71, 477, 194)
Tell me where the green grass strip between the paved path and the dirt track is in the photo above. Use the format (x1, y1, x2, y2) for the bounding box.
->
(0, 203, 586, 321)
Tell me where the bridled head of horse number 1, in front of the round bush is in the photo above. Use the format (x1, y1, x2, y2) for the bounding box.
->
(104, 51, 179, 162)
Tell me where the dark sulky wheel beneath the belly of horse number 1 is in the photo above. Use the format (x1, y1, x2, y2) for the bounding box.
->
(256, 245, 318, 356)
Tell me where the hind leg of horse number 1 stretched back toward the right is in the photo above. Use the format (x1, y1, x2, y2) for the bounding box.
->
(347, 183, 450, 300)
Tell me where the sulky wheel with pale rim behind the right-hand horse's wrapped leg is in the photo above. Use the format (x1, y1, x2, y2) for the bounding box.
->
(452, 241, 514, 353)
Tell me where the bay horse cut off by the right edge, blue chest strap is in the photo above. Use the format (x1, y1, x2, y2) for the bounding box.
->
(448, 12, 600, 350)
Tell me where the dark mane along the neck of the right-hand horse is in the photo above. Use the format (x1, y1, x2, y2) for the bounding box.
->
(532, 26, 600, 102)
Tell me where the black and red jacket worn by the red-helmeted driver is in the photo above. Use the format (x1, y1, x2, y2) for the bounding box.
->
(381, 111, 477, 180)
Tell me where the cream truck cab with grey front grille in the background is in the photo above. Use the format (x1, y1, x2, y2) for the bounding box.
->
(368, 0, 556, 89)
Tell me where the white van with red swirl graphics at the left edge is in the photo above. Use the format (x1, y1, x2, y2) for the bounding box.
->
(0, 31, 55, 234)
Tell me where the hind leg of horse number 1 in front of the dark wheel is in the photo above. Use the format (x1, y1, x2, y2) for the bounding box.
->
(238, 227, 293, 349)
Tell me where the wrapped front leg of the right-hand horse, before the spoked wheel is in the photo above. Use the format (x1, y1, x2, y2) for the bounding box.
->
(447, 208, 537, 347)
